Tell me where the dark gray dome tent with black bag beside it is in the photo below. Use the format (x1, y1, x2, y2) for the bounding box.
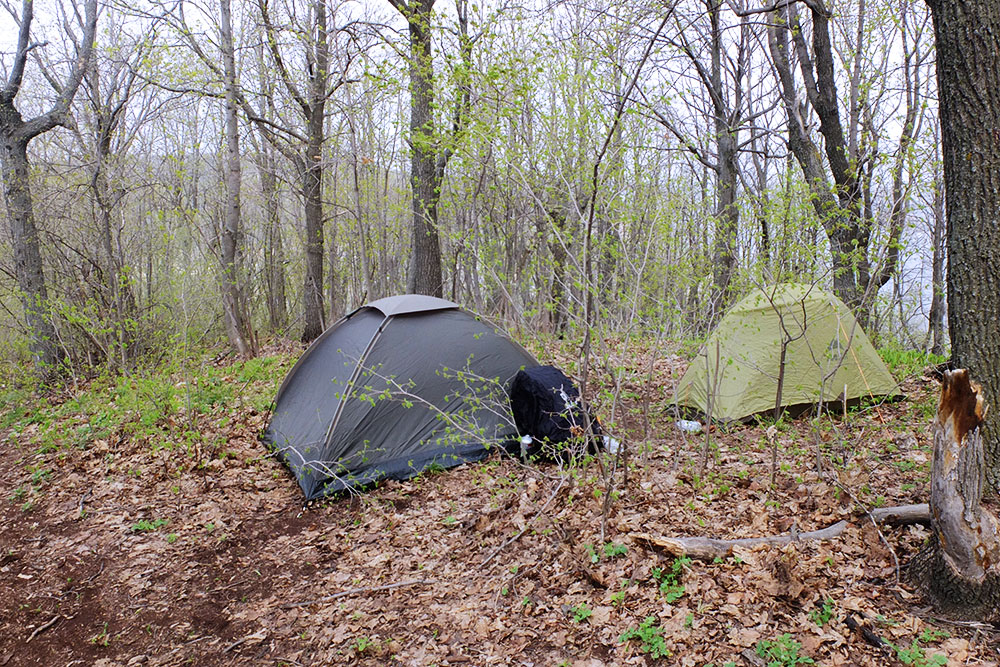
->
(263, 294, 538, 500)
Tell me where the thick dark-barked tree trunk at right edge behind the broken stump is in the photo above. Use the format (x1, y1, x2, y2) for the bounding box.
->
(928, 0, 1000, 490)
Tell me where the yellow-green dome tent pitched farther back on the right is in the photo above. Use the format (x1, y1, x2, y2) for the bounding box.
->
(674, 283, 899, 421)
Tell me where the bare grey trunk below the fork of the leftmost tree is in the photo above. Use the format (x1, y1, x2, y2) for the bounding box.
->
(0, 137, 61, 370)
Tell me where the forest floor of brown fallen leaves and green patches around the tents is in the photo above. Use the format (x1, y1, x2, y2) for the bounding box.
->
(0, 342, 1000, 667)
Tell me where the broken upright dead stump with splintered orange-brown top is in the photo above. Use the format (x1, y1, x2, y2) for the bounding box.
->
(910, 369, 1000, 622)
